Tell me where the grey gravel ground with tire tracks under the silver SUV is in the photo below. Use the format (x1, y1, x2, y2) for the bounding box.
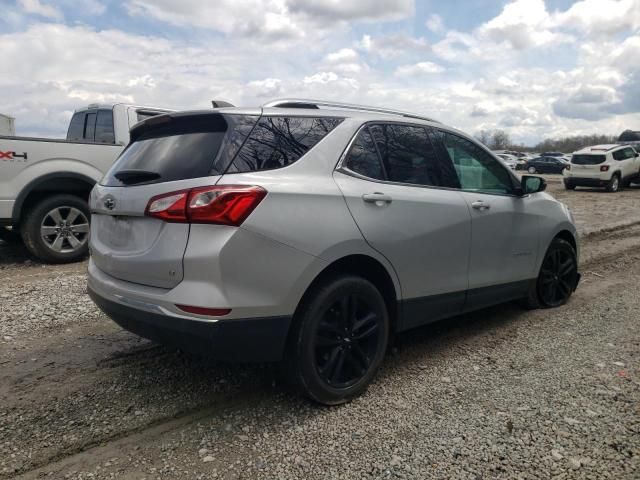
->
(0, 178, 640, 479)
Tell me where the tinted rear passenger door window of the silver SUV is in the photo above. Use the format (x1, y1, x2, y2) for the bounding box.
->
(369, 124, 458, 187)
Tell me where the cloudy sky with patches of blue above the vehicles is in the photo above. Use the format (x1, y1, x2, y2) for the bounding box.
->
(0, 0, 640, 143)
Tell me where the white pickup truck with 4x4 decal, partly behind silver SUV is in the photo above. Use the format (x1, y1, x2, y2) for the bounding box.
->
(0, 103, 169, 263)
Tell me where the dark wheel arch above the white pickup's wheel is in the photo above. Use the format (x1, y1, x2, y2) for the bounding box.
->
(11, 172, 96, 224)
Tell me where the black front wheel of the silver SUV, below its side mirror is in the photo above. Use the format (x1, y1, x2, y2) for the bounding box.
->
(521, 238, 578, 309)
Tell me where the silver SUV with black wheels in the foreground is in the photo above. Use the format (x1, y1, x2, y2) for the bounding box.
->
(89, 100, 579, 404)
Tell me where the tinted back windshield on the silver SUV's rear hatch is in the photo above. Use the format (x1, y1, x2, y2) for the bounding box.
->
(103, 114, 228, 187)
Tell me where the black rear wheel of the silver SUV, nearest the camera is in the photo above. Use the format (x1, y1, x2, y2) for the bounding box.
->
(283, 275, 389, 405)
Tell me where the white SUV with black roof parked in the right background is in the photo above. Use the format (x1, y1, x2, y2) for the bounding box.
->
(563, 145, 640, 192)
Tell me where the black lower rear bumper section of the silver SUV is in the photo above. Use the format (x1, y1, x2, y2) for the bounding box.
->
(88, 287, 291, 362)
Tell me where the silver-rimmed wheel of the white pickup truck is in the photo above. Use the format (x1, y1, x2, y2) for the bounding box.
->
(21, 195, 90, 263)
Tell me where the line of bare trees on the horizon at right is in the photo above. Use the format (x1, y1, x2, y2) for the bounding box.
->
(475, 129, 618, 153)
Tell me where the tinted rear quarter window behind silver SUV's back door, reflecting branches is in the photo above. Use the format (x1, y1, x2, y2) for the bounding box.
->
(228, 117, 342, 173)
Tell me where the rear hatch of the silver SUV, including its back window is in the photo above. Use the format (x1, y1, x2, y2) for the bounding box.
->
(90, 111, 259, 288)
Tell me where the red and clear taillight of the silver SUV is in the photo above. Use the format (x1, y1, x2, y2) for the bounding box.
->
(145, 185, 267, 227)
